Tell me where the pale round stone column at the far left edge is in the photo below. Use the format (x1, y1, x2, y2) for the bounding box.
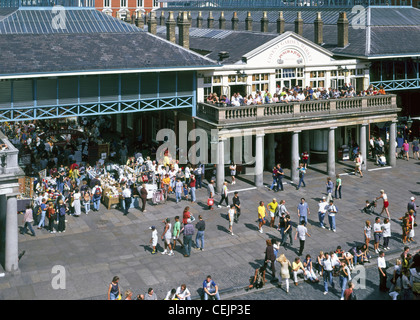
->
(4, 196, 19, 272)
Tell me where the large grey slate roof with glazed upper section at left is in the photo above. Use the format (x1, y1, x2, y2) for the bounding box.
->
(0, 8, 216, 77)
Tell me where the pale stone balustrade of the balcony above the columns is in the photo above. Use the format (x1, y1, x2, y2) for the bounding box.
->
(197, 94, 397, 124)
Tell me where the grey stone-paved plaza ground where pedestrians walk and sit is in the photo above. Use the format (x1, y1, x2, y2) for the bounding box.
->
(0, 156, 420, 300)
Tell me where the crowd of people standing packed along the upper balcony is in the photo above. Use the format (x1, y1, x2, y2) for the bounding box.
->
(206, 83, 386, 107)
